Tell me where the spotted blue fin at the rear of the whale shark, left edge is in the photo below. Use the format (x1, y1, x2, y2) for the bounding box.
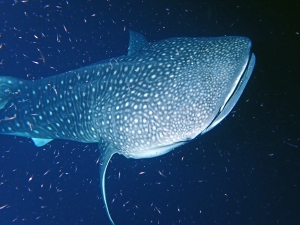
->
(0, 76, 22, 109)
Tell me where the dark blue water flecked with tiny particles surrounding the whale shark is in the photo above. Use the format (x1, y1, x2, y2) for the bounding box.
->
(0, 0, 300, 225)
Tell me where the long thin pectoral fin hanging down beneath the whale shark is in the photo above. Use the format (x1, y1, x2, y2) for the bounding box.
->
(99, 141, 116, 225)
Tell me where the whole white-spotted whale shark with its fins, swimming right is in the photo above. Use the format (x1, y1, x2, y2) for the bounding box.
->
(0, 32, 255, 224)
